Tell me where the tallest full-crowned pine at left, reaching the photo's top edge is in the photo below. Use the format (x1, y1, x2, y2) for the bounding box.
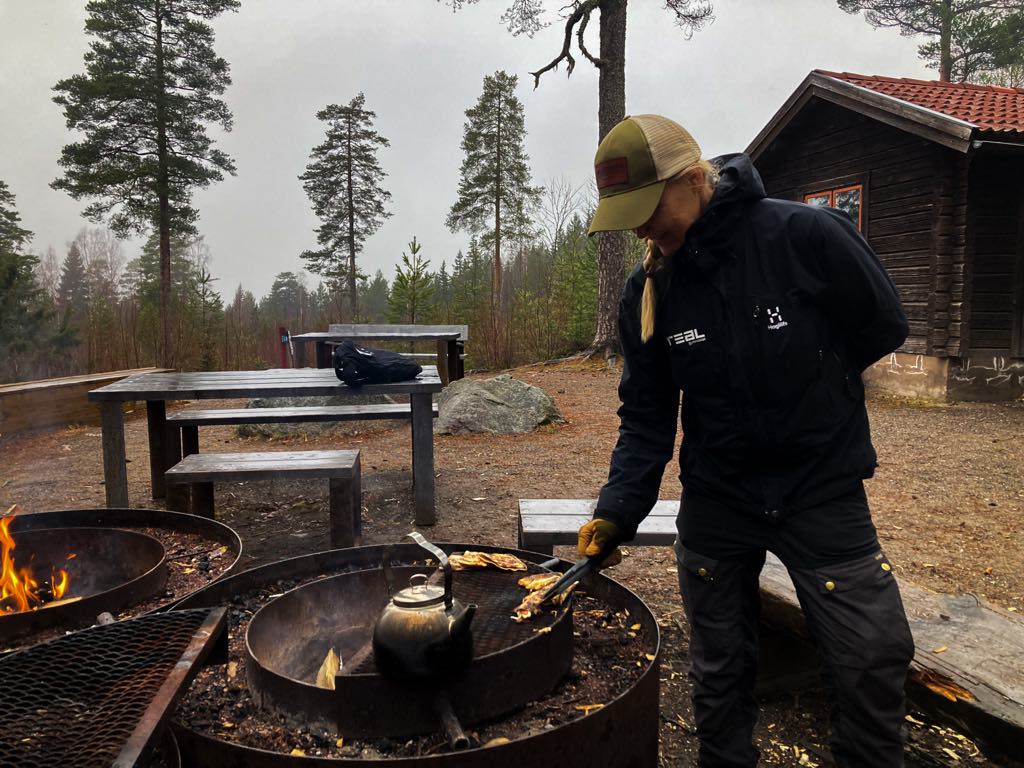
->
(52, 0, 239, 366)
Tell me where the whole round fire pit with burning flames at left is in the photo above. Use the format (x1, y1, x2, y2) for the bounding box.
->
(0, 509, 242, 652)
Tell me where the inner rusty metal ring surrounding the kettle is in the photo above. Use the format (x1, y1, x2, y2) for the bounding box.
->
(246, 563, 572, 738)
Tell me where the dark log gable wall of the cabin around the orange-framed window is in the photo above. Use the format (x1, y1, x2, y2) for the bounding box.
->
(756, 98, 968, 357)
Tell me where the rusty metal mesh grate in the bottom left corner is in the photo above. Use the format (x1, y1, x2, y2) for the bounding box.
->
(0, 608, 224, 768)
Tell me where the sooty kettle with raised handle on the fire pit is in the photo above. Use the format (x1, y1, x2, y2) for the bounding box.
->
(374, 531, 476, 679)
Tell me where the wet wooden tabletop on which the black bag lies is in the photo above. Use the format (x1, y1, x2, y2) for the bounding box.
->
(89, 366, 442, 401)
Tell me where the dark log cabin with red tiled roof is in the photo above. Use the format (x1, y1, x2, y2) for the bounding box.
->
(746, 70, 1024, 400)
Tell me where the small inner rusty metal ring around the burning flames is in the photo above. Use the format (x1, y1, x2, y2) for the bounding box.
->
(0, 528, 167, 642)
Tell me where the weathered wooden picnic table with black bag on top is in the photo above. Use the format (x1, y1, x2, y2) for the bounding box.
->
(89, 366, 442, 525)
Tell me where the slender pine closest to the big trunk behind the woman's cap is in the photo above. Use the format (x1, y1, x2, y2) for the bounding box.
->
(446, 70, 542, 311)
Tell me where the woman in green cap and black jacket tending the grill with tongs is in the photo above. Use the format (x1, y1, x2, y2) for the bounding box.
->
(579, 115, 913, 768)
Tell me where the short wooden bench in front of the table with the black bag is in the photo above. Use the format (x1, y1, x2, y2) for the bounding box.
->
(165, 451, 362, 548)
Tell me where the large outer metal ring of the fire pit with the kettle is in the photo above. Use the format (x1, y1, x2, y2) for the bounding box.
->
(172, 544, 660, 768)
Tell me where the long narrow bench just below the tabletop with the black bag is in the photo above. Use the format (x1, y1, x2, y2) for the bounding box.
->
(167, 402, 437, 456)
